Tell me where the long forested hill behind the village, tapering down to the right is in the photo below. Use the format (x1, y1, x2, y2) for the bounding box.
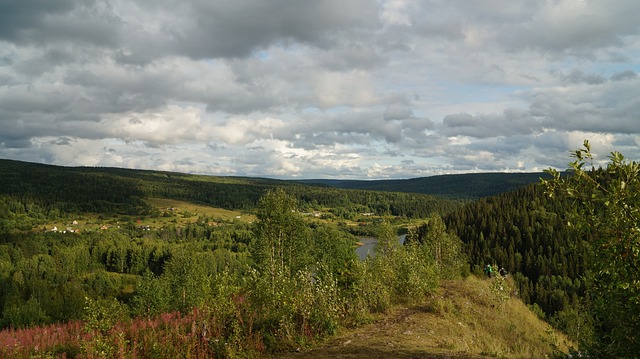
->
(0, 159, 462, 217)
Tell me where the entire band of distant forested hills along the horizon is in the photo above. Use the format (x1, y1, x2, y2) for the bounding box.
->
(0, 159, 548, 208)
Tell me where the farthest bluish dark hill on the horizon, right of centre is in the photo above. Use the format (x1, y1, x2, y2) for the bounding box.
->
(300, 172, 548, 200)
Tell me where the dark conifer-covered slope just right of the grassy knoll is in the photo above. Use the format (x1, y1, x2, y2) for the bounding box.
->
(445, 185, 591, 329)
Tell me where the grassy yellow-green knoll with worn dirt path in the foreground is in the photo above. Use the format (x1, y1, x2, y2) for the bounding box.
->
(277, 277, 572, 359)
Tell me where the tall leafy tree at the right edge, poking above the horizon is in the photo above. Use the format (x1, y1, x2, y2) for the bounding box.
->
(543, 141, 640, 357)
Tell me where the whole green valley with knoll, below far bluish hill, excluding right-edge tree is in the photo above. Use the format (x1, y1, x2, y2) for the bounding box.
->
(0, 154, 633, 358)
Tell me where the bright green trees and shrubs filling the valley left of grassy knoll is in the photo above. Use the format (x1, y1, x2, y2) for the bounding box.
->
(0, 190, 464, 357)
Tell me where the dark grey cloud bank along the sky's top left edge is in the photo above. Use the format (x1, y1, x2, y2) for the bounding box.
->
(0, 0, 378, 64)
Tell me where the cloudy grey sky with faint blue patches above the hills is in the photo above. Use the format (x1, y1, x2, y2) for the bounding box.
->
(0, 0, 640, 179)
